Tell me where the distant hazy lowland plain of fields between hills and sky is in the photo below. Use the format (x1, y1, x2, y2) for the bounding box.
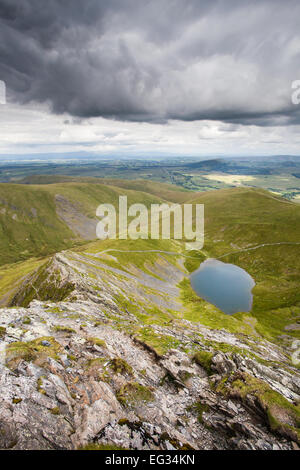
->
(4, 157, 300, 203)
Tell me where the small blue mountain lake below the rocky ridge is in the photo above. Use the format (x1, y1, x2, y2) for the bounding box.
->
(190, 258, 255, 315)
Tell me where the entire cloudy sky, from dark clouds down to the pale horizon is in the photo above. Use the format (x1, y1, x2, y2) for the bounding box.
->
(0, 0, 300, 157)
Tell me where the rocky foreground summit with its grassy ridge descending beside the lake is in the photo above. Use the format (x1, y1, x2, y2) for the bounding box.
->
(0, 246, 300, 450)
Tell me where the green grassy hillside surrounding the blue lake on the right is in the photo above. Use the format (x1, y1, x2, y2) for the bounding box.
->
(179, 188, 300, 339)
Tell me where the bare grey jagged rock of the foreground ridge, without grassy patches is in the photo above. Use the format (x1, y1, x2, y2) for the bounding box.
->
(0, 252, 300, 450)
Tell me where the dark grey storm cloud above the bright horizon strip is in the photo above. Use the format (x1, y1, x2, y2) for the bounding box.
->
(0, 0, 300, 125)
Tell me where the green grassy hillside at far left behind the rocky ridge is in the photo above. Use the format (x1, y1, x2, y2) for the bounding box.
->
(0, 183, 169, 265)
